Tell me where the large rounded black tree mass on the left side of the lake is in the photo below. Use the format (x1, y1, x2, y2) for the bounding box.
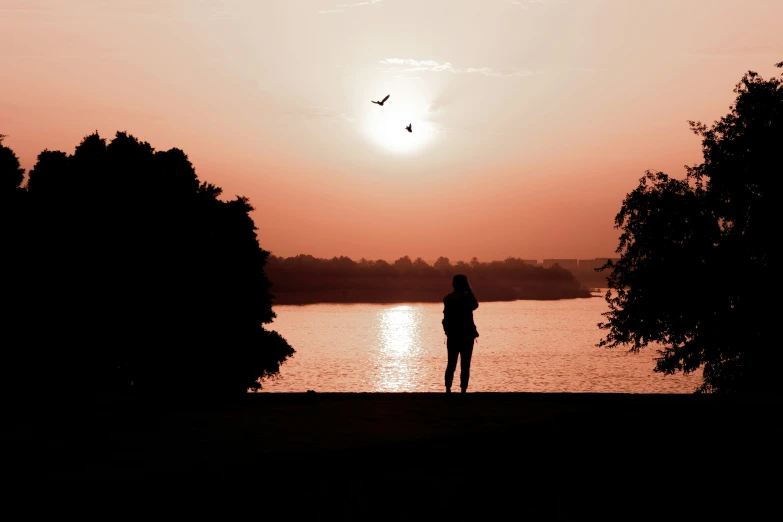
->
(0, 132, 294, 395)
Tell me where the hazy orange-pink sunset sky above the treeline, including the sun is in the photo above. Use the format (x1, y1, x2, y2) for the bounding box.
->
(0, 0, 783, 261)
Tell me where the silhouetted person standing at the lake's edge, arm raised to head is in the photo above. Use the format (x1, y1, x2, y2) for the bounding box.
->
(443, 274, 478, 393)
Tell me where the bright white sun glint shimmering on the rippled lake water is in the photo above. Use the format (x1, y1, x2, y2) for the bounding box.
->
(369, 305, 424, 392)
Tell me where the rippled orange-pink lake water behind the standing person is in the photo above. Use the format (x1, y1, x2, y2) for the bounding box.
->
(262, 294, 701, 393)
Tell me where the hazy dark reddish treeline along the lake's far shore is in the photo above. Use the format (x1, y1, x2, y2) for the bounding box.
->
(266, 254, 590, 304)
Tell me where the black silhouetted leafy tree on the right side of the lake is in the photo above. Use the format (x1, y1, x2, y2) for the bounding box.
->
(599, 62, 783, 393)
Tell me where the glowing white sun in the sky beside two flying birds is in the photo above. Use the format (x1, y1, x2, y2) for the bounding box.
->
(364, 93, 437, 154)
